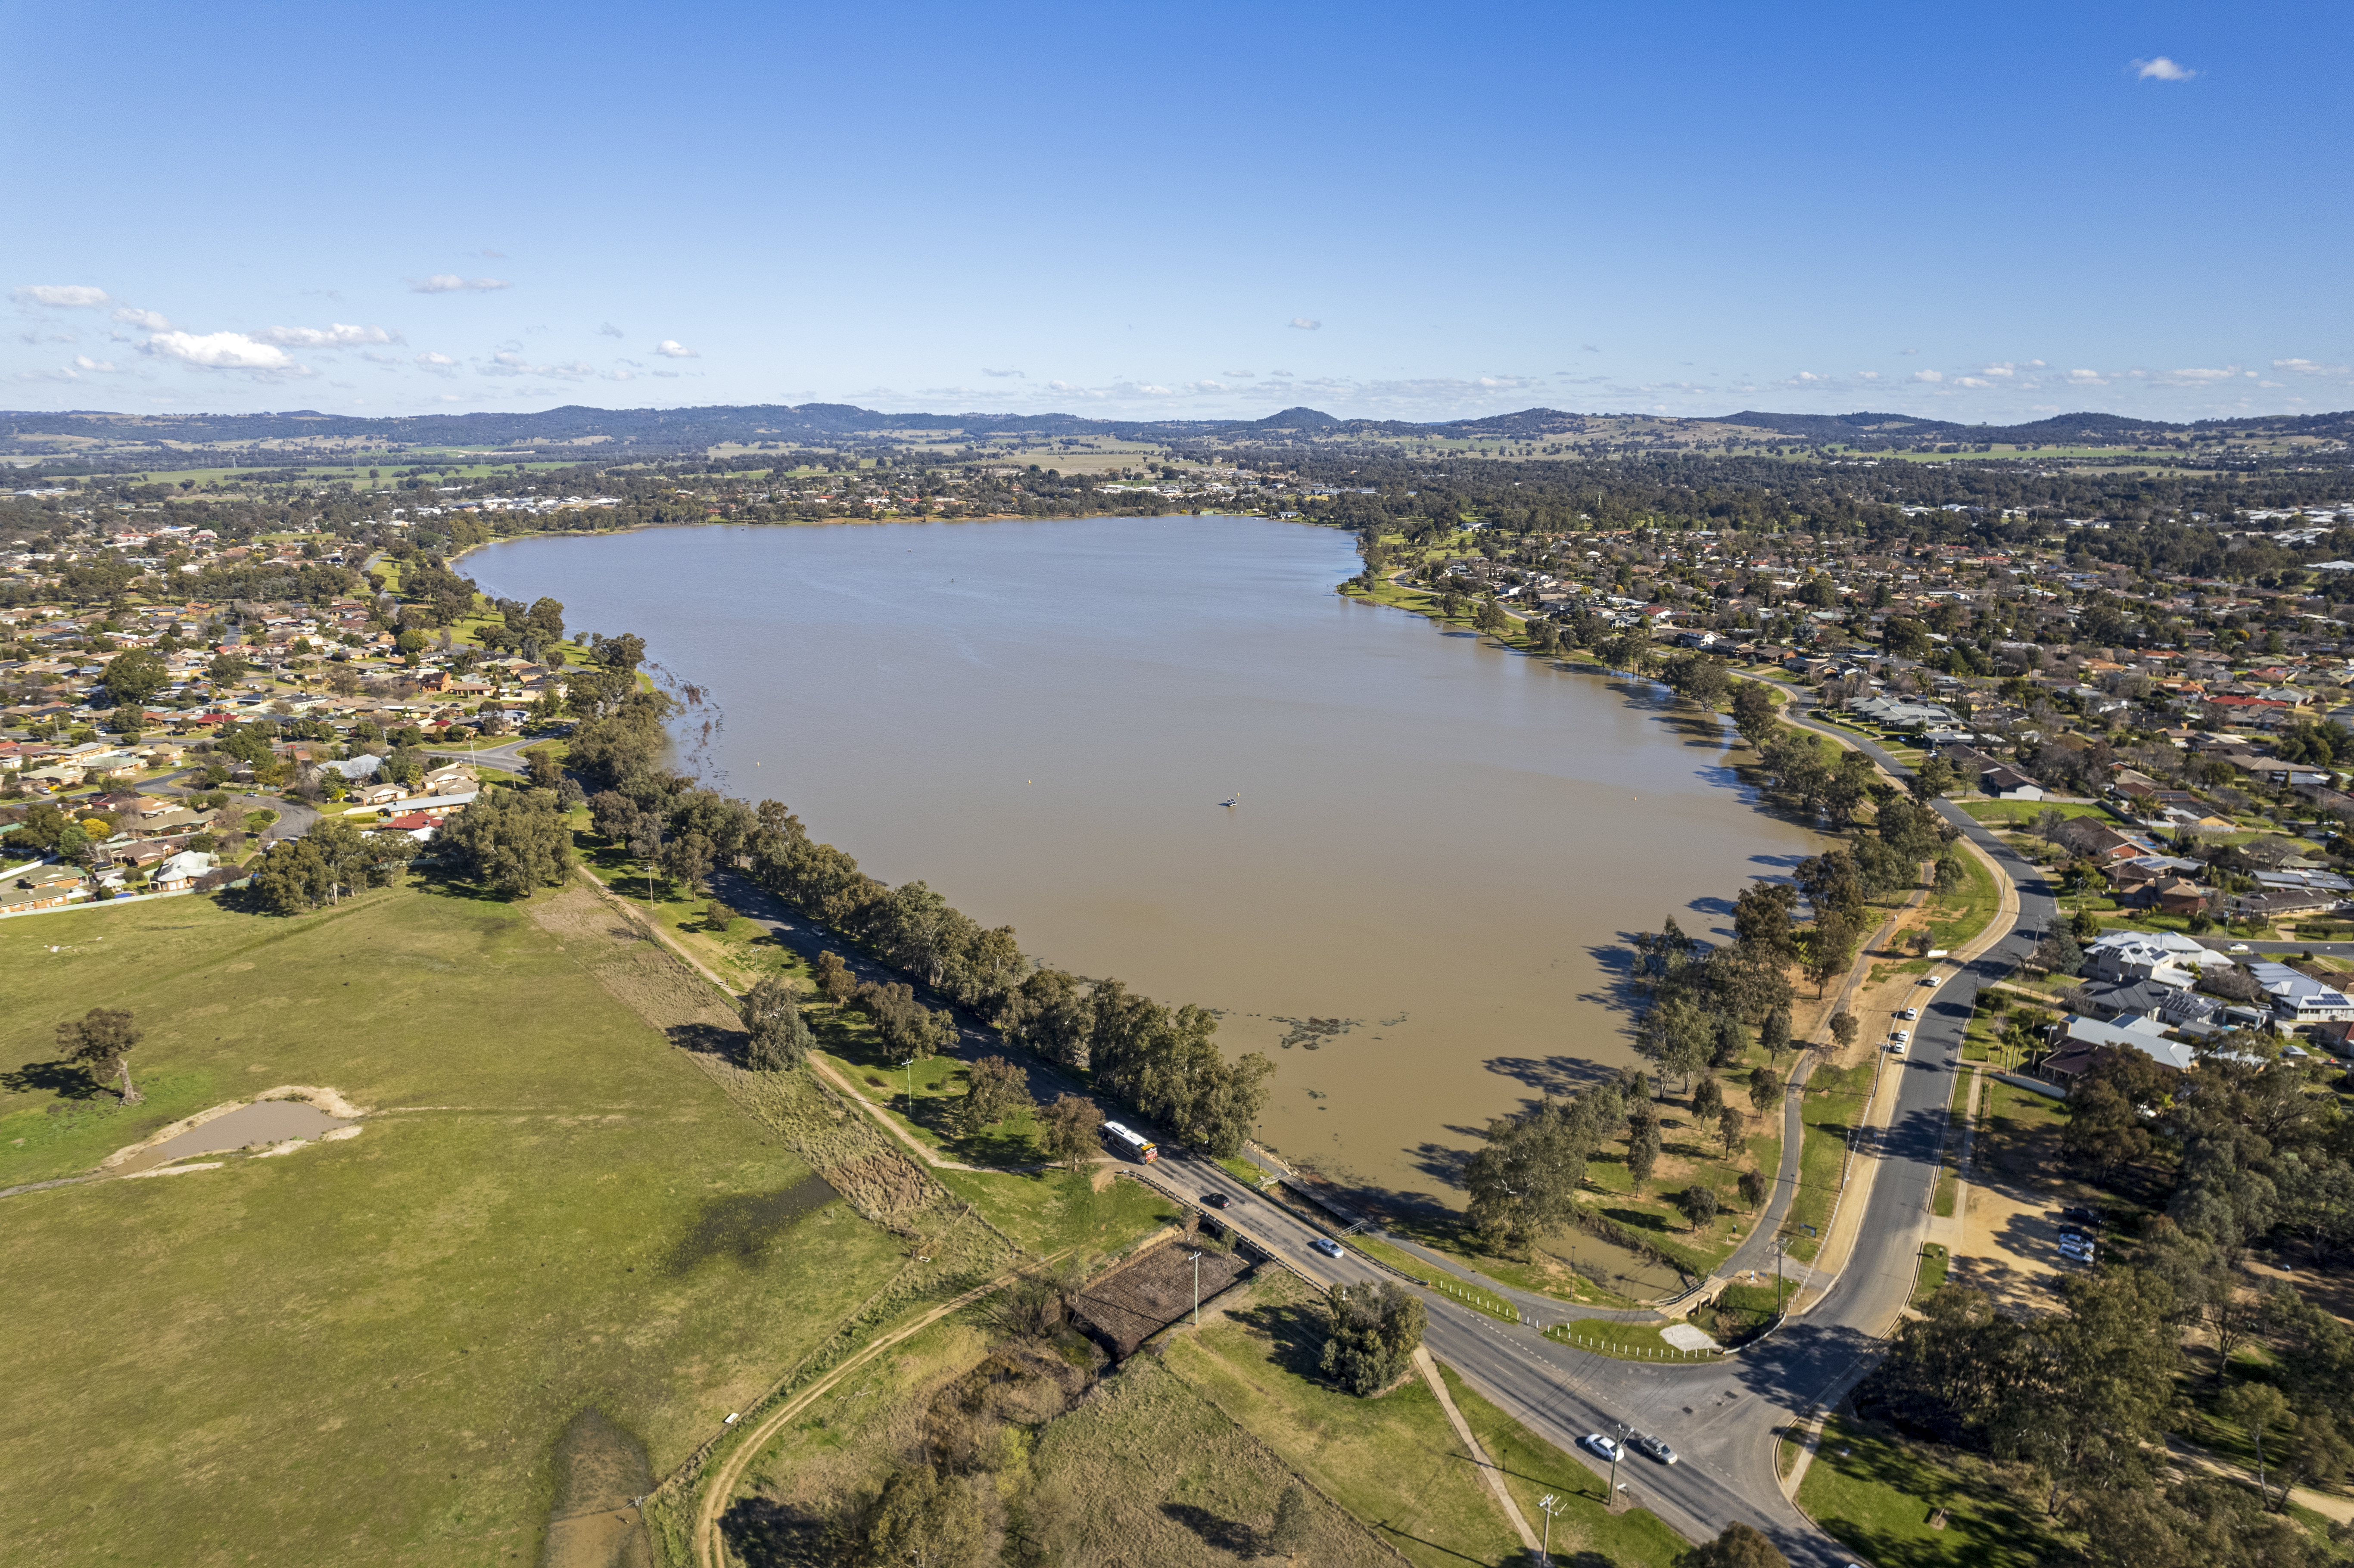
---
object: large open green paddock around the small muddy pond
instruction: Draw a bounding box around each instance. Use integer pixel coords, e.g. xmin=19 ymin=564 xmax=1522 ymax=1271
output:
xmin=0 ymin=890 xmax=906 ymax=1563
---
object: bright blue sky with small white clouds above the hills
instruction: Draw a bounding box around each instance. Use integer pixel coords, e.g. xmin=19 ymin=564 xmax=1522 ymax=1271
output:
xmin=0 ymin=0 xmax=2354 ymax=421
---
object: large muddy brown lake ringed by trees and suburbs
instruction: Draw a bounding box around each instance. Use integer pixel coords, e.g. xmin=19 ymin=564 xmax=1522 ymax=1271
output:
xmin=466 ymin=516 xmax=1815 ymax=1224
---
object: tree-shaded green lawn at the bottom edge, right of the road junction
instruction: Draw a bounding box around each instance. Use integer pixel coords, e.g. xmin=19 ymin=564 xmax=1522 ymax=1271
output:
xmin=1798 ymin=1415 xmax=2074 ymax=1568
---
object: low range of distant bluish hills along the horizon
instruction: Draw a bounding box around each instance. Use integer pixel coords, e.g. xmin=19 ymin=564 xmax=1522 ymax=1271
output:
xmin=0 ymin=403 xmax=2354 ymax=461
